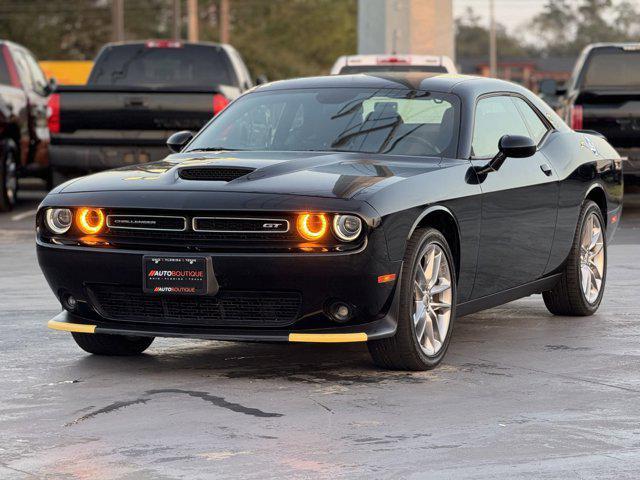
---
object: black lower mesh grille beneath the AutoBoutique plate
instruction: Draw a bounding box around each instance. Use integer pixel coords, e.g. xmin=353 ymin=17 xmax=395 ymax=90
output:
xmin=88 ymin=285 xmax=302 ymax=327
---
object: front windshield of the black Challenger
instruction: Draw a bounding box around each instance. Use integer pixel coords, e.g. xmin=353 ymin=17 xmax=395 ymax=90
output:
xmin=189 ymin=88 xmax=459 ymax=157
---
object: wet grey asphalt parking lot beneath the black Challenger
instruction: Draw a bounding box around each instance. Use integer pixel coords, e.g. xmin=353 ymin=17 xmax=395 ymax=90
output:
xmin=0 ymin=182 xmax=640 ymax=480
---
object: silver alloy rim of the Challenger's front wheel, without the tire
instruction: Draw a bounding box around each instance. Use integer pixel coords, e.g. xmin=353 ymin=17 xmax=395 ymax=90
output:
xmin=413 ymin=243 xmax=452 ymax=357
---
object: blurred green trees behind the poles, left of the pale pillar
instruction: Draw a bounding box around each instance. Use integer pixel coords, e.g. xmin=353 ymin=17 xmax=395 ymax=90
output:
xmin=0 ymin=0 xmax=357 ymax=79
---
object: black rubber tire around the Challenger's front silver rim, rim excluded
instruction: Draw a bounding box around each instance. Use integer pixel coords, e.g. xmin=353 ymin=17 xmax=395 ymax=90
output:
xmin=367 ymin=228 xmax=457 ymax=370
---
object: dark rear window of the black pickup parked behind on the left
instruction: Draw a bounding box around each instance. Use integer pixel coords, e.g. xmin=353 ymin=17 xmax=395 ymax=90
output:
xmin=89 ymin=44 xmax=237 ymax=87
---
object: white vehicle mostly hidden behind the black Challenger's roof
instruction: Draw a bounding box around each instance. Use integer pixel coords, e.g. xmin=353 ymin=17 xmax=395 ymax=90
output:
xmin=331 ymin=55 xmax=457 ymax=75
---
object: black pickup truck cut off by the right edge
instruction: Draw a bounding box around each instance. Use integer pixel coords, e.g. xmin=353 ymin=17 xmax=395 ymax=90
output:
xmin=558 ymin=43 xmax=640 ymax=180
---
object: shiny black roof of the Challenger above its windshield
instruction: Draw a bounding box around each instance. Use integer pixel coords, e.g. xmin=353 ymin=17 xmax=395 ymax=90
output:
xmin=255 ymin=72 xmax=527 ymax=96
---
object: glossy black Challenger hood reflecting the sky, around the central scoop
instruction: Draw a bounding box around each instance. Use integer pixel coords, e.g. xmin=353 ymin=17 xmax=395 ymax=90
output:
xmin=54 ymin=151 xmax=441 ymax=198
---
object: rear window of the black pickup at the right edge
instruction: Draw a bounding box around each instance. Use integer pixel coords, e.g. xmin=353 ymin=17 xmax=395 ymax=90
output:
xmin=582 ymin=48 xmax=640 ymax=90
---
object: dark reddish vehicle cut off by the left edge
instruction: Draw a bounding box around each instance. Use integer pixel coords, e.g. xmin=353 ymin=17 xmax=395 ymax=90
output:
xmin=0 ymin=40 xmax=55 ymax=211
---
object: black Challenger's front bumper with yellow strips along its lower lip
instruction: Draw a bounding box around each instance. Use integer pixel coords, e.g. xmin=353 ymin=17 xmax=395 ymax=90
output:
xmin=37 ymin=239 xmax=401 ymax=341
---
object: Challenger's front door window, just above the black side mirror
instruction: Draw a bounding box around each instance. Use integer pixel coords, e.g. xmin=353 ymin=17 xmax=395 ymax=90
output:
xmin=471 ymin=96 xmax=530 ymax=158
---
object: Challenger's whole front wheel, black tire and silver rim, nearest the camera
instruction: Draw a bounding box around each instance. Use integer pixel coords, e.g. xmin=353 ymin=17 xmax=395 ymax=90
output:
xmin=368 ymin=228 xmax=456 ymax=370
